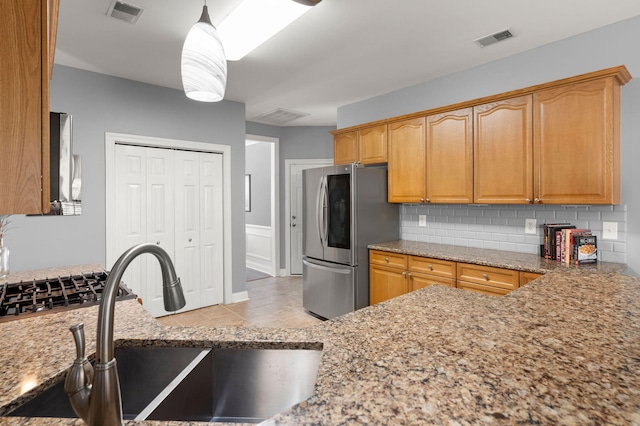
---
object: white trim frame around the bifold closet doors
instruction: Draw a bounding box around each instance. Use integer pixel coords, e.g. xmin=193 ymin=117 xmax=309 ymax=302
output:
xmin=104 ymin=132 xmax=235 ymax=303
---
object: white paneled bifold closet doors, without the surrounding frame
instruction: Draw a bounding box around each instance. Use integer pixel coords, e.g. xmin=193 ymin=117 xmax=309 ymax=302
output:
xmin=115 ymin=145 xmax=224 ymax=317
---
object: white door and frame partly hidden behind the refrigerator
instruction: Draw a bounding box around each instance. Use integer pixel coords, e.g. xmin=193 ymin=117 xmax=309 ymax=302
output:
xmin=285 ymin=158 xmax=333 ymax=275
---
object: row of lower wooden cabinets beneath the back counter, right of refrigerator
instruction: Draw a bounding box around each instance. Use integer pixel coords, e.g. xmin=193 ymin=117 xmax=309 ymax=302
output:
xmin=369 ymin=250 xmax=542 ymax=305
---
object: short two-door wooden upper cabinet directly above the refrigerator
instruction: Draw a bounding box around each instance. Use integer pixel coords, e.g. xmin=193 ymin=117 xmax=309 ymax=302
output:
xmin=333 ymin=124 xmax=387 ymax=164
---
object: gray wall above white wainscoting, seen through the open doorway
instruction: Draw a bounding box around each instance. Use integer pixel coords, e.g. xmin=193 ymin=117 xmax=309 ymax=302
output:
xmin=245 ymin=142 xmax=273 ymax=226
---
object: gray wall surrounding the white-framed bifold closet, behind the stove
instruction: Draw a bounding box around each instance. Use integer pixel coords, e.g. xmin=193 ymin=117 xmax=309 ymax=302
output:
xmin=6 ymin=66 xmax=246 ymax=292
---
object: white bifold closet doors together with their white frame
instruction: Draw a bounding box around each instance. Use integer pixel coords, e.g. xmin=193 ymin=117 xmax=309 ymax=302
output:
xmin=105 ymin=133 xmax=232 ymax=316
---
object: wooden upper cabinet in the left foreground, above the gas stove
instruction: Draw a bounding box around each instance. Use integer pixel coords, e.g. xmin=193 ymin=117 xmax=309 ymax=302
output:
xmin=0 ymin=0 xmax=58 ymax=214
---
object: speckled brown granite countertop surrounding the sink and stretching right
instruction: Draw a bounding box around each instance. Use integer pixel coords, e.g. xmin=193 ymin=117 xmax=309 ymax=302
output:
xmin=0 ymin=248 xmax=640 ymax=425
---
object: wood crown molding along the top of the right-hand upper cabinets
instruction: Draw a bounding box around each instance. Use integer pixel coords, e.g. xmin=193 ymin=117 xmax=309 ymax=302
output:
xmin=329 ymin=65 xmax=632 ymax=136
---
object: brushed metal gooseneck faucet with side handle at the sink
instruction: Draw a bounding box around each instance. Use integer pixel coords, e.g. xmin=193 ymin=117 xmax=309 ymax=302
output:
xmin=64 ymin=244 xmax=185 ymax=426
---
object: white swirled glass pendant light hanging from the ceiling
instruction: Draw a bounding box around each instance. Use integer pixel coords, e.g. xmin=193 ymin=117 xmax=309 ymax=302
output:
xmin=182 ymin=0 xmax=227 ymax=102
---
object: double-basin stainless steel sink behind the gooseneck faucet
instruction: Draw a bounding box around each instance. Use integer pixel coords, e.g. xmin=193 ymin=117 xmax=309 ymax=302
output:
xmin=9 ymin=347 xmax=322 ymax=423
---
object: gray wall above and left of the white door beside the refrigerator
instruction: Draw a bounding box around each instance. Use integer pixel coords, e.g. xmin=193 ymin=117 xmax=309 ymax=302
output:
xmin=247 ymin=122 xmax=336 ymax=269
